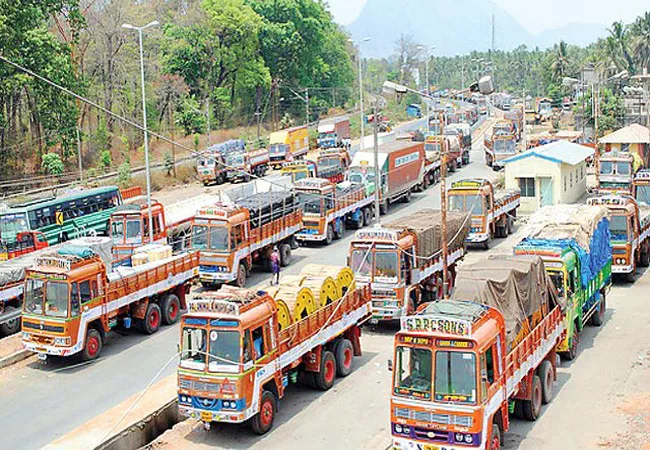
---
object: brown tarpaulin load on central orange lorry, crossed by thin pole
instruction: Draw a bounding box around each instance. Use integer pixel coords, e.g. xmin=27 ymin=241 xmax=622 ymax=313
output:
xmin=383 ymin=209 xmax=471 ymax=266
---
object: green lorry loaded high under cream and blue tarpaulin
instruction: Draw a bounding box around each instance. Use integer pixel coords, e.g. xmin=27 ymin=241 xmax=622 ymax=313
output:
xmin=514 ymin=205 xmax=612 ymax=360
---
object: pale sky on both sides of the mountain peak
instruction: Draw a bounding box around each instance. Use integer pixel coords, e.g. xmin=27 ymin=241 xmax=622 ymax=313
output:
xmin=326 ymin=0 xmax=650 ymax=35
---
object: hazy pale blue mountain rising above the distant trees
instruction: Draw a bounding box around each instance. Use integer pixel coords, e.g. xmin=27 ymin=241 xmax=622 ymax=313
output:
xmin=347 ymin=0 xmax=533 ymax=57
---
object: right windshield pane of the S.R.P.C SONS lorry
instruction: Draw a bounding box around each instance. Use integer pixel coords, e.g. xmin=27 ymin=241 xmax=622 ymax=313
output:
xmin=434 ymin=351 xmax=476 ymax=404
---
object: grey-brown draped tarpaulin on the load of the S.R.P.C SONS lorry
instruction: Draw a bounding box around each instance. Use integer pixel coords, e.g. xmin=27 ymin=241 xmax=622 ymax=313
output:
xmin=451 ymin=255 xmax=564 ymax=351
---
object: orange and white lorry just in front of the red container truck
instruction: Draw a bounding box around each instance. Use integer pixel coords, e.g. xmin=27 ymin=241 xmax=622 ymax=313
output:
xmin=294 ymin=178 xmax=375 ymax=244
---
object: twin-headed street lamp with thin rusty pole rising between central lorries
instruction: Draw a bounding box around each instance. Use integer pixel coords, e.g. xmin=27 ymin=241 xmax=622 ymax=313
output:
xmin=382 ymin=76 xmax=494 ymax=297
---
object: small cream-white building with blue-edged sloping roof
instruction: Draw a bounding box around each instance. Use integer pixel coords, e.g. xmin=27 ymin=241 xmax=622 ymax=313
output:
xmin=503 ymin=141 xmax=594 ymax=212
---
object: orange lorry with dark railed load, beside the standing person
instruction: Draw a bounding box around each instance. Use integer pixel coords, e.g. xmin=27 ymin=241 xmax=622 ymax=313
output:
xmin=191 ymin=179 xmax=303 ymax=287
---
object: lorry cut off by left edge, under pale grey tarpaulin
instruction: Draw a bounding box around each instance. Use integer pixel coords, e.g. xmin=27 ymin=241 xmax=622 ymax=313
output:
xmin=0 ymin=237 xmax=110 ymax=335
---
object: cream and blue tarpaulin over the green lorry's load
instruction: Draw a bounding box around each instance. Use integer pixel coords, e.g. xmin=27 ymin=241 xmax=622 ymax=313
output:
xmin=515 ymin=205 xmax=612 ymax=287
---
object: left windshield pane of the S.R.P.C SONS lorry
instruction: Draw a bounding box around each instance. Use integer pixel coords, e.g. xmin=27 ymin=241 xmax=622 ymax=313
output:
xmin=393 ymin=347 xmax=432 ymax=400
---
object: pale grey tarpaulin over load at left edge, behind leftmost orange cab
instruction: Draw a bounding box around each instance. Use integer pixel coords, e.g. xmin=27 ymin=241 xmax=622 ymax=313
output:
xmin=0 ymin=237 xmax=112 ymax=288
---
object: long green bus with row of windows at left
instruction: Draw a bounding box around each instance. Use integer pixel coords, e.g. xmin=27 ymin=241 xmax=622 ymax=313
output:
xmin=0 ymin=186 xmax=122 ymax=245
